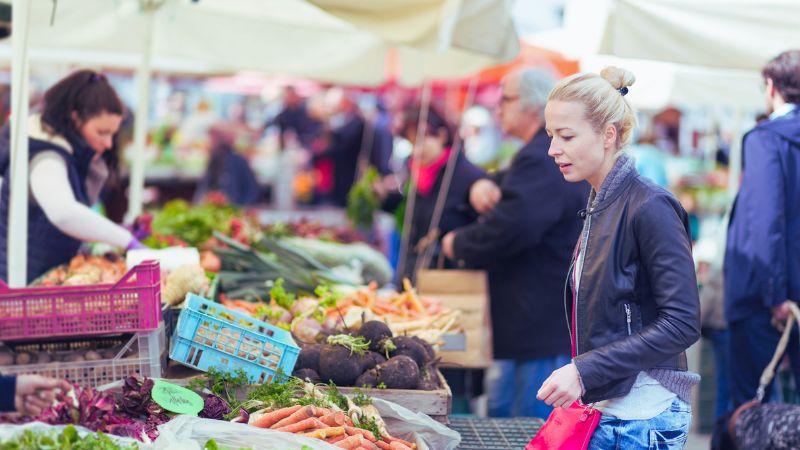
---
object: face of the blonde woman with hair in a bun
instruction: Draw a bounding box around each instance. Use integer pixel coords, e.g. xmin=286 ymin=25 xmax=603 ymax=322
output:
xmin=544 ymin=100 xmax=616 ymax=190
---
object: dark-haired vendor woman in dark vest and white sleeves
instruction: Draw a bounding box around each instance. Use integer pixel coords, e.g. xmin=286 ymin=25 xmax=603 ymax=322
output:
xmin=0 ymin=70 xmax=141 ymax=283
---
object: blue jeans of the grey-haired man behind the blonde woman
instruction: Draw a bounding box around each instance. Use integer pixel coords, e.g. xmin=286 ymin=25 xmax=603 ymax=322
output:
xmin=486 ymin=355 xmax=570 ymax=419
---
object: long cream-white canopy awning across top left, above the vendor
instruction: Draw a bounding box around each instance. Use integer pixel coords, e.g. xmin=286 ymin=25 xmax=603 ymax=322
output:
xmin=0 ymin=0 xmax=519 ymax=85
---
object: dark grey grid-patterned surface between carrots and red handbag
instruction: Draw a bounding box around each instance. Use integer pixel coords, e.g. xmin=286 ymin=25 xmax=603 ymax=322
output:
xmin=449 ymin=416 xmax=544 ymax=450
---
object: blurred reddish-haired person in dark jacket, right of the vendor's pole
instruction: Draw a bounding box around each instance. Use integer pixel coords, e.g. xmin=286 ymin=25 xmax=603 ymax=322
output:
xmin=195 ymin=123 xmax=261 ymax=206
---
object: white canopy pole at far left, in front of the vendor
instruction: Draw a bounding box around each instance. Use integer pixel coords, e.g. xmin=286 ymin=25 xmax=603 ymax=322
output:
xmin=7 ymin=0 xmax=31 ymax=287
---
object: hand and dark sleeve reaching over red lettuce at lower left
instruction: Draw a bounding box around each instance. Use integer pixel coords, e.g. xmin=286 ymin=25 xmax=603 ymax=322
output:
xmin=0 ymin=375 xmax=72 ymax=416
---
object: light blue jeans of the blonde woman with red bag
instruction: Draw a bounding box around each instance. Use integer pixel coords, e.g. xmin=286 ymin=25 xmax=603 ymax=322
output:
xmin=589 ymin=399 xmax=692 ymax=450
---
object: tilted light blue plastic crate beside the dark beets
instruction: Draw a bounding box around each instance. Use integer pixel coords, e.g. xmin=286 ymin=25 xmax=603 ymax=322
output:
xmin=169 ymin=294 xmax=300 ymax=384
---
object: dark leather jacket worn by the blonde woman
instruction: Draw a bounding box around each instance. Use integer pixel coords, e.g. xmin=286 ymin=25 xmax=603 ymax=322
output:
xmin=565 ymin=170 xmax=700 ymax=403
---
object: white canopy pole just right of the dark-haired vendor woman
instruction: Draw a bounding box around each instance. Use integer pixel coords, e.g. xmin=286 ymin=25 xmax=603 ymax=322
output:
xmin=125 ymin=6 xmax=156 ymax=223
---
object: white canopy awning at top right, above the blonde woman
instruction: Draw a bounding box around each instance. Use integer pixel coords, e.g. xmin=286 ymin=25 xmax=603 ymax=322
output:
xmin=599 ymin=0 xmax=800 ymax=71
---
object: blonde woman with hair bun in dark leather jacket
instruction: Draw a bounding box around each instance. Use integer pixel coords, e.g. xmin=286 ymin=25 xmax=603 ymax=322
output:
xmin=537 ymin=67 xmax=700 ymax=449
